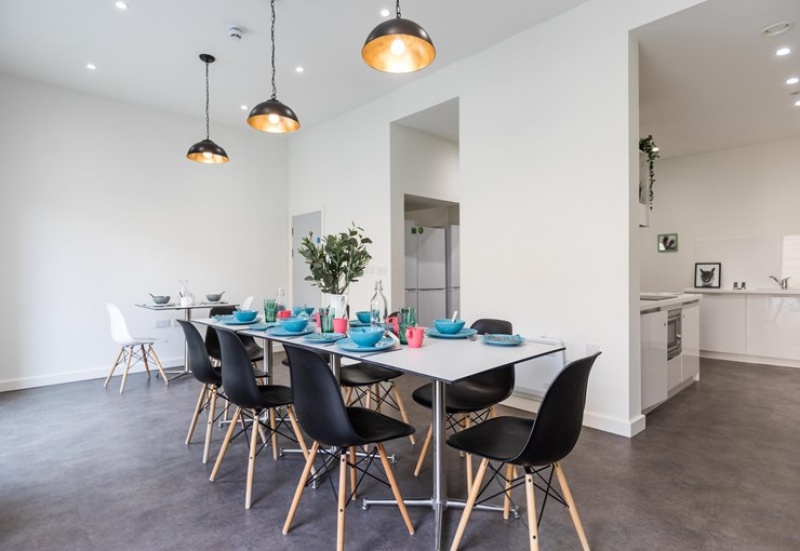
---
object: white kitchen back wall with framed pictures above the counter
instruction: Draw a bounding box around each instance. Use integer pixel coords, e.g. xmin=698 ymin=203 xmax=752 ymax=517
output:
xmin=640 ymin=139 xmax=800 ymax=291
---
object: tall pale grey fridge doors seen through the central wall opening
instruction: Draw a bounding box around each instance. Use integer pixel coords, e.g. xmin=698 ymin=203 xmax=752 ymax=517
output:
xmin=405 ymin=221 xmax=461 ymax=327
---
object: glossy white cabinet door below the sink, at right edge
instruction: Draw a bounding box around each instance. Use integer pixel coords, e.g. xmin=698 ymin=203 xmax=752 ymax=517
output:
xmin=747 ymin=295 xmax=800 ymax=360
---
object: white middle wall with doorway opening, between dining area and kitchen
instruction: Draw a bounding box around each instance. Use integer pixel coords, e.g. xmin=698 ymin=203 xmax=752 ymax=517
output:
xmin=289 ymin=0 xmax=698 ymax=440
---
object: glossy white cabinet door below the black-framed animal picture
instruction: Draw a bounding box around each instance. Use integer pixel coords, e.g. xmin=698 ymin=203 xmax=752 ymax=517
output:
xmin=700 ymin=294 xmax=747 ymax=354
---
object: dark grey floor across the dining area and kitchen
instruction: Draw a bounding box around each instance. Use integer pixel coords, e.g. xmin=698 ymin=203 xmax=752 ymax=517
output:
xmin=0 ymin=360 xmax=800 ymax=551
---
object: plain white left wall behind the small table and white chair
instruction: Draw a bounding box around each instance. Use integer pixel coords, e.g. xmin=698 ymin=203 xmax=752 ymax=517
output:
xmin=0 ymin=75 xmax=288 ymax=392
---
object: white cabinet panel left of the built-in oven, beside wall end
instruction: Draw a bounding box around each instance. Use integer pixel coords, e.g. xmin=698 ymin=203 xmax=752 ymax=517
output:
xmin=641 ymin=310 xmax=668 ymax=410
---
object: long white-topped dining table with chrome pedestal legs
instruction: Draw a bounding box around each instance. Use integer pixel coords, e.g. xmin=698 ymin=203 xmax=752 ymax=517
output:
xmin=194 ymin=318 xmax=564 ymax=551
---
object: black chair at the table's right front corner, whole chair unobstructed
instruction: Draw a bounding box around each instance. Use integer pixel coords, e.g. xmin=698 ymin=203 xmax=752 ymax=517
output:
xmin=447 ymin=352 xmax=600 ymax=551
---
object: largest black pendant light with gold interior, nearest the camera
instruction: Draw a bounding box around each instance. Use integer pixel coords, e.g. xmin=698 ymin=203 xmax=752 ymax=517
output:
xmin=361 ymin=0 xmax=436 ymax=73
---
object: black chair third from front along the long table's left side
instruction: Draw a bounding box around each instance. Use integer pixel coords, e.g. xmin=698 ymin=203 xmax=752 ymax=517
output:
xmin=177 ymin=320 xmax=227 ymax=463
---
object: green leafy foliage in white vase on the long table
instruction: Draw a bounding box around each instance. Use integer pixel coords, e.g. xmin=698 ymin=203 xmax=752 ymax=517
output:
xmin=297 ymin=223 xmax=372 ymax=295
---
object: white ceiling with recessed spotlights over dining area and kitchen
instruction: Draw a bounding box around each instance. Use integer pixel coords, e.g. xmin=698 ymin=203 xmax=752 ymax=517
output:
xmin=0 ymin=0 xmax=800 ymax=158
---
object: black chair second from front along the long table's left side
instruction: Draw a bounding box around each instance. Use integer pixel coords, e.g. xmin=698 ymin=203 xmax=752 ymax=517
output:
xmin=210 ymin=330 xmax=308 ymax=509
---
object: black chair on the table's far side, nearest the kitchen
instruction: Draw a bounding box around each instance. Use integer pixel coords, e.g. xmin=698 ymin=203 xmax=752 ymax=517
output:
xmin=411 ymin=318 xmax=514 ymax=486
